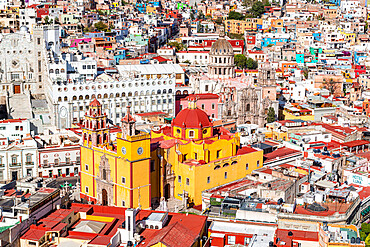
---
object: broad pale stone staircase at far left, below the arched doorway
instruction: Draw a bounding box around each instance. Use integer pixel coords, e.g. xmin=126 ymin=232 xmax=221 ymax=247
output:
xmin=7 ymin=94 xmax=33 ymax=119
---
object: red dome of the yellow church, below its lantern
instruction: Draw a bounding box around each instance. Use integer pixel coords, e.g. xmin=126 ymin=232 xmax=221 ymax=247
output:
xmin=172 ymin=108 xmax=212 ymax=129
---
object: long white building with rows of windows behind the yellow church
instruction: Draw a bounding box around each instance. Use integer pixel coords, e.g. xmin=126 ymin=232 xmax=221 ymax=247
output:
xmin=50 ymin=64 xmax=185 ymax=128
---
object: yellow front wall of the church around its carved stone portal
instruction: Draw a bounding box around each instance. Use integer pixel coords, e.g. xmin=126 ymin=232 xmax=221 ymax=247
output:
xmin=81 ymin=131 xmax=151 ymax=208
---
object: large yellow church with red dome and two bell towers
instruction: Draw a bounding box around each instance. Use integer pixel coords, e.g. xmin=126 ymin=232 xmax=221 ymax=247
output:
xmin=81 ymin=98 xmax=263 ymax=208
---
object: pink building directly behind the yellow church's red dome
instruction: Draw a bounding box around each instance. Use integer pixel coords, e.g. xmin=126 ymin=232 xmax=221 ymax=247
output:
xmin=176 ymin=93 xmax=219 ymax=119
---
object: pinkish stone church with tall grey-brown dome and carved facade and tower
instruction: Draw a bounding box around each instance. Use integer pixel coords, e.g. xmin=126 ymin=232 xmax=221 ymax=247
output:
xmin=190 ymin=29 xmax=278 ymax=127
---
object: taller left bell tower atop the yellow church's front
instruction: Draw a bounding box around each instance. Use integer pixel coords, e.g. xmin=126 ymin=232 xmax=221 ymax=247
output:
xmin=82 ymin=99 xmax=110 ymax=147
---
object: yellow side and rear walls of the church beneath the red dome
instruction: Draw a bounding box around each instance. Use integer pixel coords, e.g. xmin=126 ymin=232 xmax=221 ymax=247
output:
xmin=162 ymin=135 xmax=263 ymax=205
